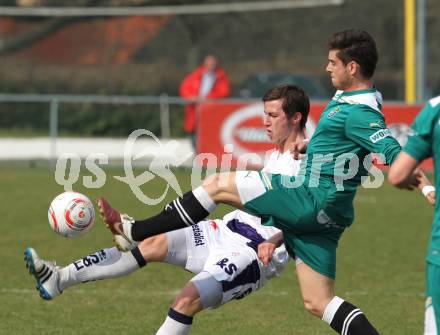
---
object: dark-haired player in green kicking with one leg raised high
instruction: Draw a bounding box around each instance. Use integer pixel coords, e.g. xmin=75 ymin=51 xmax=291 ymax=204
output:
xmin=101 ymin=30 xmax=401 ymax=335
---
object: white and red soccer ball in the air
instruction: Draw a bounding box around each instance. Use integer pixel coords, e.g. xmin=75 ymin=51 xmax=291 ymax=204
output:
xmin=47 ymin=192 xmax=95 ymax=237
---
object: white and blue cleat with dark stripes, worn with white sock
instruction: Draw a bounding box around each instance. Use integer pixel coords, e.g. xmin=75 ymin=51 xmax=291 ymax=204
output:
xmin=24 ymin=247 xmax=63 ymax=300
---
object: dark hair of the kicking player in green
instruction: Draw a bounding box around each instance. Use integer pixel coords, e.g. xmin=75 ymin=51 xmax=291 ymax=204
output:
xmin=328 ymin=29 xmax=379 ymax=79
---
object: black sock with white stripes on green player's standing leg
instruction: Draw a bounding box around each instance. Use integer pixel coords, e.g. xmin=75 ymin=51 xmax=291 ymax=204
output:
xmin=330 ymin=301 xmax=379 ymax=335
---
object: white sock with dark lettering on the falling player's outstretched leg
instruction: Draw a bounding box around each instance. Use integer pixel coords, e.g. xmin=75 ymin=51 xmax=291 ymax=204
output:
xmin=59 ymin=247 xmax=140 ymax=290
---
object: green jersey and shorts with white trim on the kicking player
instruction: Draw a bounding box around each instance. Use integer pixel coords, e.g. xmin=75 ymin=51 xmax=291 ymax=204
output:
xmin=242 ymin=89 xmax=401 ymax=278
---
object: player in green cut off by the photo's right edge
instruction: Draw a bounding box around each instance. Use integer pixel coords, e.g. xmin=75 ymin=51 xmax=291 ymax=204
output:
xmin=388 ymin=96 xmax=440 ymax=335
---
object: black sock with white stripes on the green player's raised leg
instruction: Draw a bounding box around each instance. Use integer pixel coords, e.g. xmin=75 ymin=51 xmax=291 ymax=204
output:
xmin=131 ymin=192 xmax=209 ymax=241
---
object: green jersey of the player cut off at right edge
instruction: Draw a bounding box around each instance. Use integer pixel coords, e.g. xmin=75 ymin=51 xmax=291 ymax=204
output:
xmin=403 ymin=96 xmax=440 ymax=265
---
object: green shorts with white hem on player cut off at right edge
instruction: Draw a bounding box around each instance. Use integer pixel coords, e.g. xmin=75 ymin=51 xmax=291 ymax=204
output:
xmin=425 ymin=262 xmax=440 ymax=329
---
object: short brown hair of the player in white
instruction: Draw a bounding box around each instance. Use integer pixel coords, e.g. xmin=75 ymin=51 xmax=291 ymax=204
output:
xmin=262 ymin=85 xmax=310 ymax=129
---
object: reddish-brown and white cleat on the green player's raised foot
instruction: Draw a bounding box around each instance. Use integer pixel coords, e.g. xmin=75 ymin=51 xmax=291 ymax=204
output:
xmin=98 ymin=197 xmax=138 ymax=251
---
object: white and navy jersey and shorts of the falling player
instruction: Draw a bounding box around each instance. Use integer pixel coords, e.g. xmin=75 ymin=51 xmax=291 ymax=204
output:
xmin=167 ymin=151 xmax=301 ymax=304
